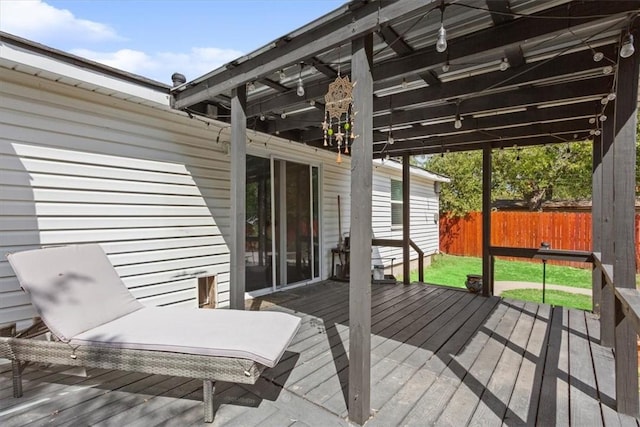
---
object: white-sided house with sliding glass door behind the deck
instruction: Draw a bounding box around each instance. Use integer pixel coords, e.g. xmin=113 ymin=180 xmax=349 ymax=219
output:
xmin=0 ymin=33 xmax=447 ymax=325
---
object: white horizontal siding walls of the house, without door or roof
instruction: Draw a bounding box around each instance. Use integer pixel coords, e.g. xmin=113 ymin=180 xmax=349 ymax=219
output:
xmin=0 ymin=69 xmax=438 ymax=324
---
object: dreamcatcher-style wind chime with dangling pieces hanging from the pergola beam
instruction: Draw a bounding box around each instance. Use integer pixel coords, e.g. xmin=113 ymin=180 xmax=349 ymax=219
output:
xmin=322 ymin=71 xmax=356 ymax=163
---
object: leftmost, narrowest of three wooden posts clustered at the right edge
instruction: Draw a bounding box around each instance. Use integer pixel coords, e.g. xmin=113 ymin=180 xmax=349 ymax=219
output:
xmin=591 ymin=135 xmax=602 ymax=315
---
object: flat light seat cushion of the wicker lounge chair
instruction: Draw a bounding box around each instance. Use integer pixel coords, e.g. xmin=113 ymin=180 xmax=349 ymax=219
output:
xmin=71 ymin=307 xmax=300 ymax=367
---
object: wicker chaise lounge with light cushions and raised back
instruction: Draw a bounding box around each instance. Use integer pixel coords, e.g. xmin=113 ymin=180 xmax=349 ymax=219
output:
xmin=0 ymin=244 xmax=300 ymax=422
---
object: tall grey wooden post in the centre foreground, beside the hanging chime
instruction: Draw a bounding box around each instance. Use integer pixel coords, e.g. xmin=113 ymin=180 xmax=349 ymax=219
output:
xmin=348 ymin=34 xmax=373 ymax=425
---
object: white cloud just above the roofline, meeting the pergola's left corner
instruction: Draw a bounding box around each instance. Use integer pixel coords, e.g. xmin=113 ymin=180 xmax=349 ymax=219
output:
xmin=71 ymin=47 xmax=242 ymax=84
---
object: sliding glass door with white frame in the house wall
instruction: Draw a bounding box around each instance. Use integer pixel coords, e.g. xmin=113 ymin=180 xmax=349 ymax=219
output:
xmin=246 ymin=156 xmax=320 ymax=291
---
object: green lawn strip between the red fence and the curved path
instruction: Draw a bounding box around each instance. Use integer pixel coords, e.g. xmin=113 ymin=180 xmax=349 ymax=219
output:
xmin=411 ymin=254 xmax=591 ymax=289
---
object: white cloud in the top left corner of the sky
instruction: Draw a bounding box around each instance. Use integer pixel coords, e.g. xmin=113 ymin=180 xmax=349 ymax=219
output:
xmin=0 ymin=0 xmax=122 ymax=43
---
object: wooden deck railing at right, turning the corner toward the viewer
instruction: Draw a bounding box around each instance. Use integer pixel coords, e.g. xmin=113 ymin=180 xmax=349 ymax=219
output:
xmin=489 ymin=246 xmax=640 ymax=416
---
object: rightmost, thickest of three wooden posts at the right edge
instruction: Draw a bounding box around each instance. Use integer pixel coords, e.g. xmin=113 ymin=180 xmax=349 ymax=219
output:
xmin=613 ymin=29 xmax=640 ymax=417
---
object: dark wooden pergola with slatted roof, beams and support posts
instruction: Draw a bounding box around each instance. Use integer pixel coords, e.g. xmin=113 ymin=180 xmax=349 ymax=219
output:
xmin=172 ymin=0 xmax=640 ymax=424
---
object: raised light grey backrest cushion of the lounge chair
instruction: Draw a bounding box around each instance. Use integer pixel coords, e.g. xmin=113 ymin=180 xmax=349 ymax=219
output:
xmin=7 ymin=244 xmax=143 ymax=342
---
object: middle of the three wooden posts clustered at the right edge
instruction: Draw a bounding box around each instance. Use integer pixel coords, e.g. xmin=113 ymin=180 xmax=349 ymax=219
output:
xmin=592 ymin=102 xmax=615 ymax=347
